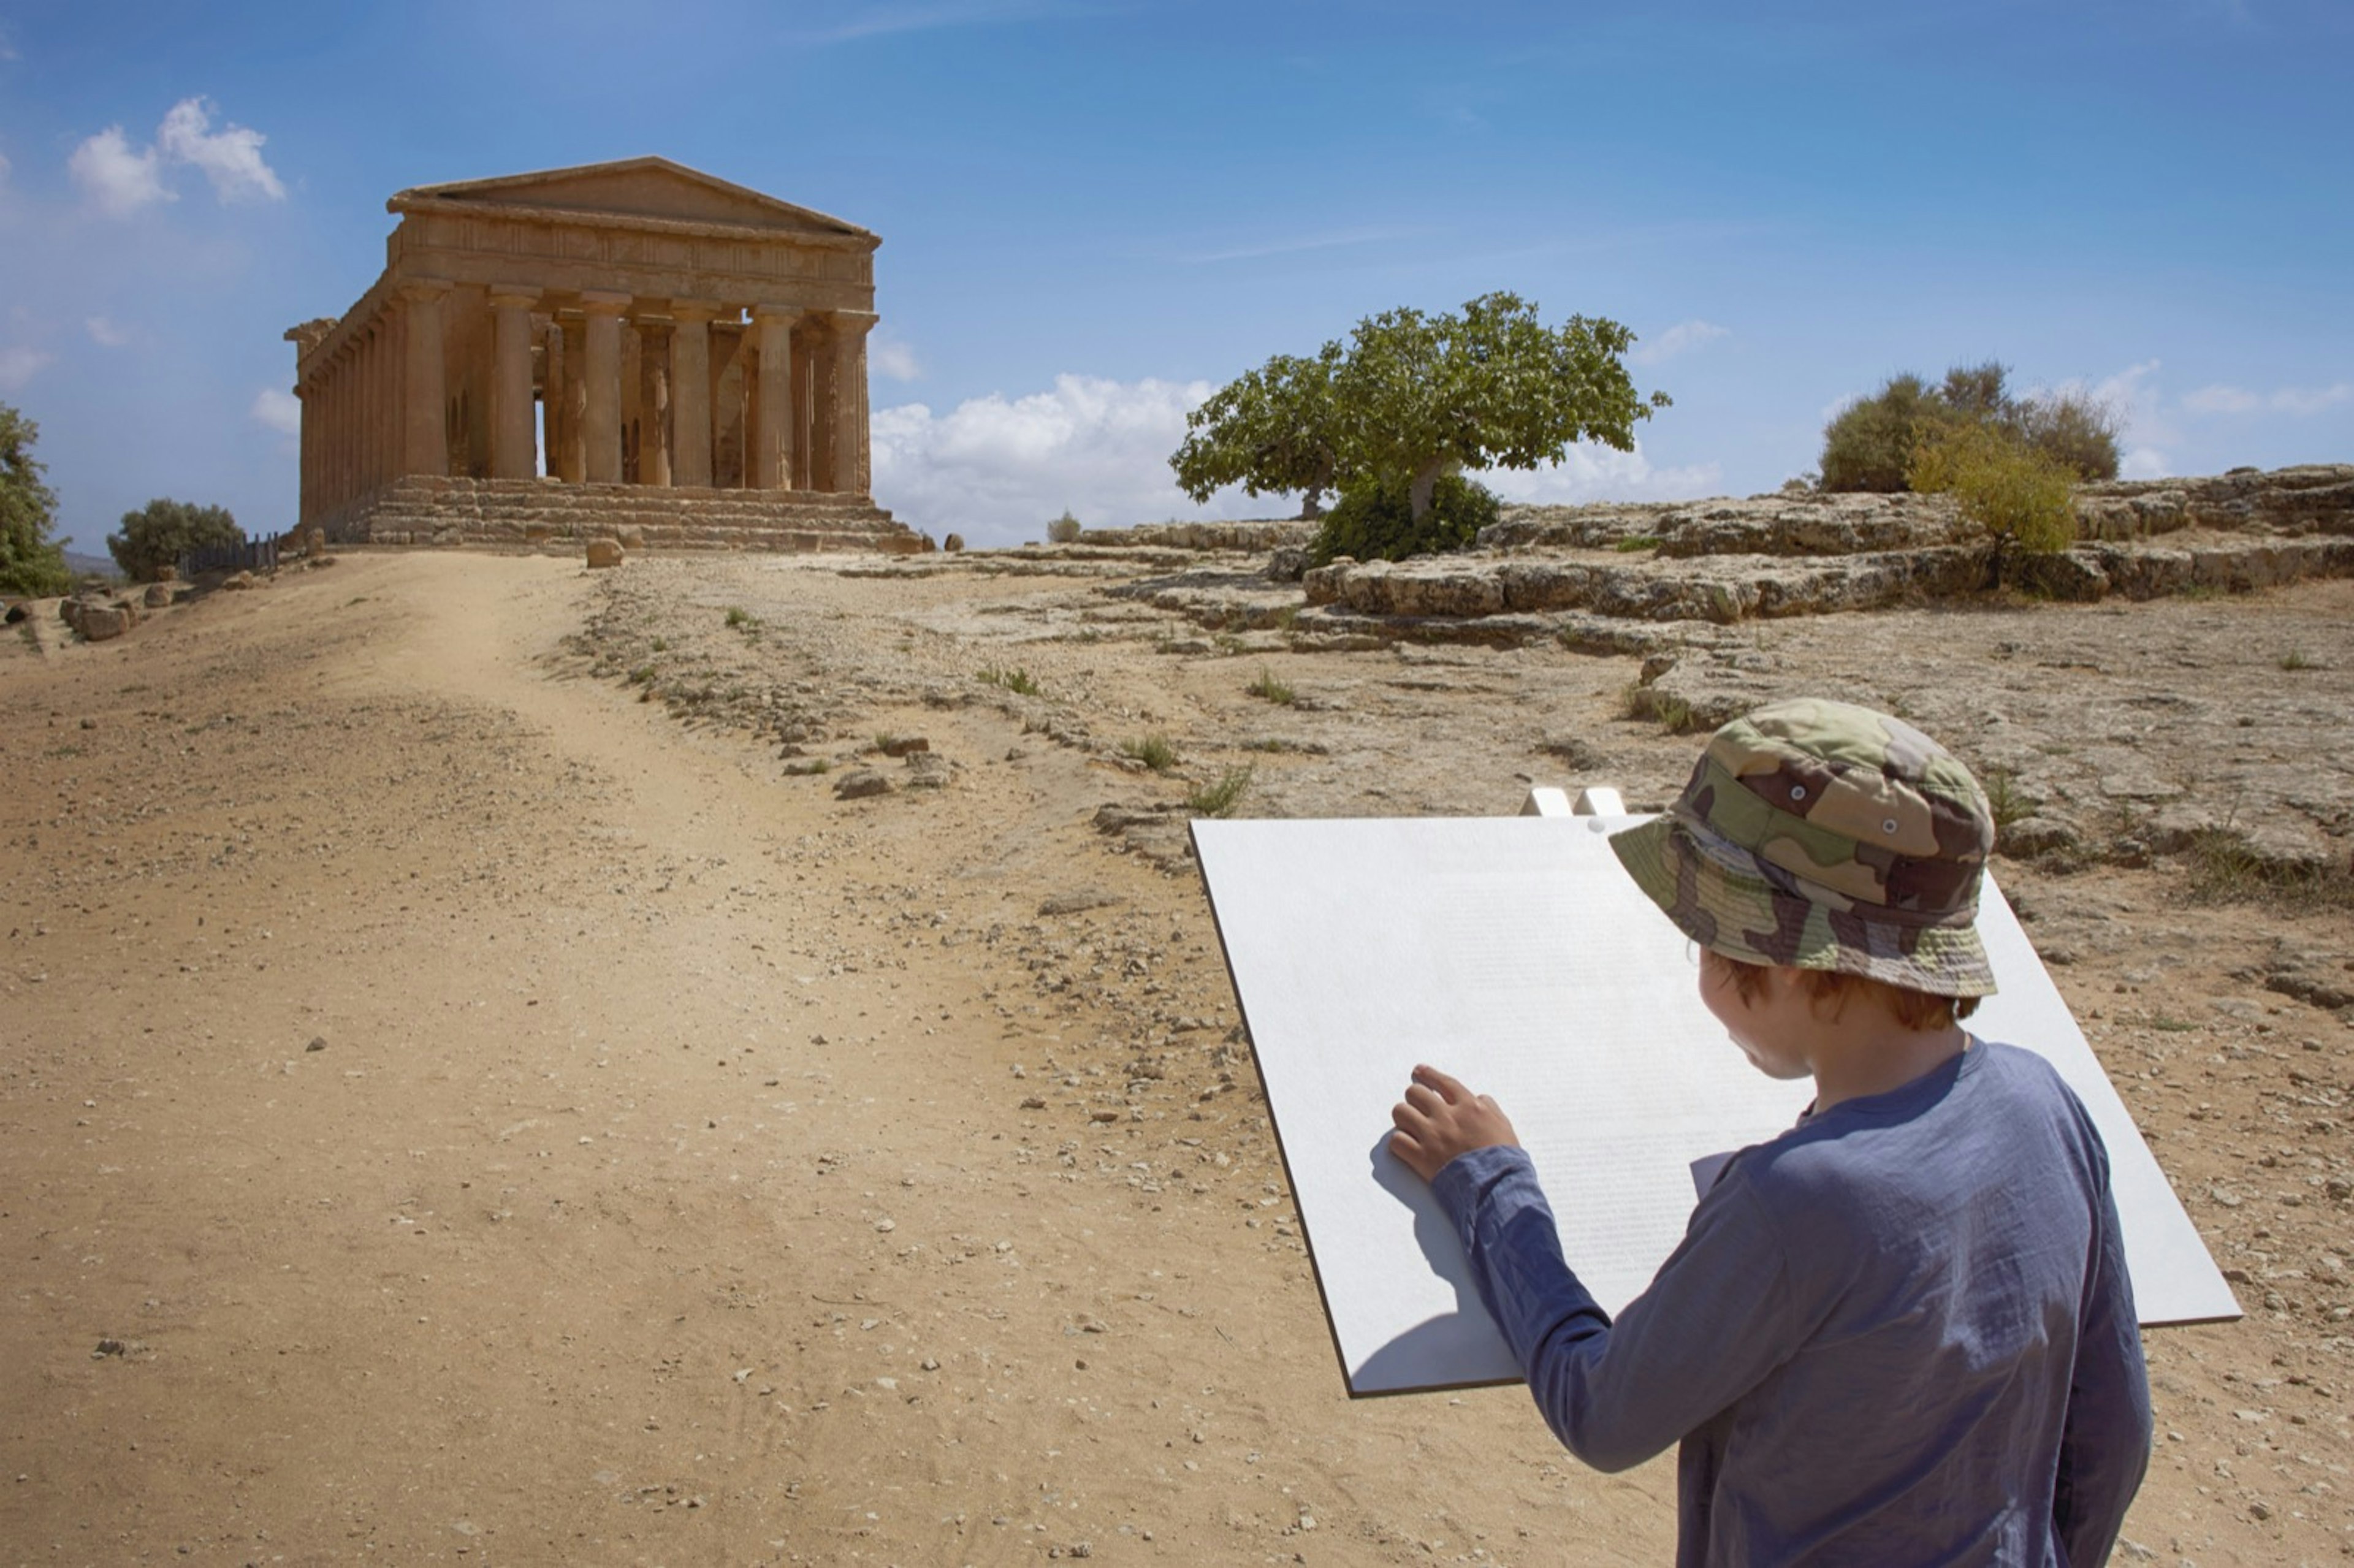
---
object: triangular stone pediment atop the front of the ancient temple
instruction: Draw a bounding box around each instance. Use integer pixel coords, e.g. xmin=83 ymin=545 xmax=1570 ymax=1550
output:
xmin=386 ymin=158 xmax=874 ymax=240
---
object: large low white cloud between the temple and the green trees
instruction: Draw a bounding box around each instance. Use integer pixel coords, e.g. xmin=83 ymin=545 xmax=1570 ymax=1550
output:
xmin=871 ymin=375 xmax=1290 ymax=544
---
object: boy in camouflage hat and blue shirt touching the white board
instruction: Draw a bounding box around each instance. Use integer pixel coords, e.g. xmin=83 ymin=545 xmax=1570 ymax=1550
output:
xmin=1391 ymin=702 xmax=2149 ymax=1568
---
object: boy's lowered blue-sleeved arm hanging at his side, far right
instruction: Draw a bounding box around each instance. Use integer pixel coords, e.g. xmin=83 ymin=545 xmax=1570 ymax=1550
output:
xmin=2052 ymin=1168 xmax=2152 ymax=1568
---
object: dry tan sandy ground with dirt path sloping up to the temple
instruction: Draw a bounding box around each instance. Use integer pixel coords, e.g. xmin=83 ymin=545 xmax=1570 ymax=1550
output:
xmin=0 ymin=544 xmax=2354 ymax=1566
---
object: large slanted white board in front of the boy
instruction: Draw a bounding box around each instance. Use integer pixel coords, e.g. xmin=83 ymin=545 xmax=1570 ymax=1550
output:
xmin=1194 ymin=817 xmax=2239 ymax=1396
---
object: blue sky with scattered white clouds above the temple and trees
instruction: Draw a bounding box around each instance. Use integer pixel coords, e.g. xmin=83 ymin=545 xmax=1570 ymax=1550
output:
xmin=0 ymin=0 xmax=2354 ymax=549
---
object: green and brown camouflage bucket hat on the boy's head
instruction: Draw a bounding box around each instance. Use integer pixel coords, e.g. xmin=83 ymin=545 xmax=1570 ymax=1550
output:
xmin=1610 ymin=699 xmax=1994 ymax=996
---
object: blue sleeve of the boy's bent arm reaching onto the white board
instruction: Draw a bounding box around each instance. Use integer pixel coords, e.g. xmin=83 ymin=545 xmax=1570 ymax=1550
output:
xmin=1431 ymin=1146 xmax=1799 ymax=1469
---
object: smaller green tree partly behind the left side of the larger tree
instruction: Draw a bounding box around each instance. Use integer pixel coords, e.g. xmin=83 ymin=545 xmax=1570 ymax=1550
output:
xmin=1170 ymin=344 xmax=1342 ymax=518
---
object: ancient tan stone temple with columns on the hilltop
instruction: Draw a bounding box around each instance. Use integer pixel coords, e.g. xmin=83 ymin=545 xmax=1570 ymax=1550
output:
xmin=287 ymin=158 xmax=918 ymax=549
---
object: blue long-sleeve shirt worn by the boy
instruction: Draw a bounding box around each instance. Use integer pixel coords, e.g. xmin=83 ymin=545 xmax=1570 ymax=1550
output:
xmin=1431 ymin=1043 xmax=2149 ymax=1568
